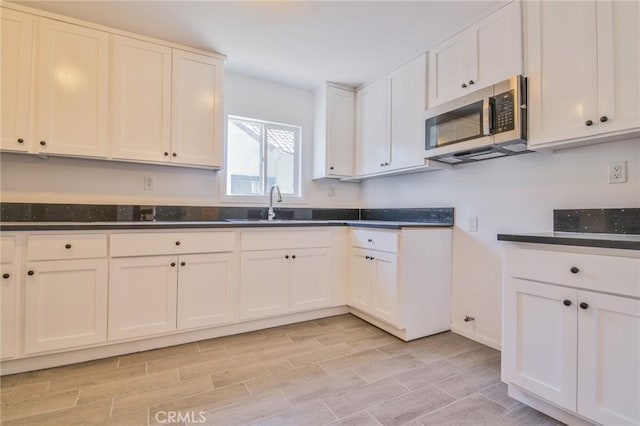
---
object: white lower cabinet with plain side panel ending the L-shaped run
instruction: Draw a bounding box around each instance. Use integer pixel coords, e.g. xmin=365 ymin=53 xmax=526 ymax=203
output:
xmin=349 ymin=228 xmax=452 ymax=340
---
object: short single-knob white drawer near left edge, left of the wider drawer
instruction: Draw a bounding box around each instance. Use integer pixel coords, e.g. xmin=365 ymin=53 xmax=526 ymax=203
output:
xmin=27 ymin=234 xmax=107 ymax=261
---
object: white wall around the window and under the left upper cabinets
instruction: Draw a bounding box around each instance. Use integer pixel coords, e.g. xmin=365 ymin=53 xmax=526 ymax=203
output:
xmin=0 ymin=73 xmax=360 ymax=207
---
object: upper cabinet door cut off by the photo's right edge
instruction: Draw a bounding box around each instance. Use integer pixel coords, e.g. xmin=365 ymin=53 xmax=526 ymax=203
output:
xmin=596 ymin=0 xmax=640 ymax=133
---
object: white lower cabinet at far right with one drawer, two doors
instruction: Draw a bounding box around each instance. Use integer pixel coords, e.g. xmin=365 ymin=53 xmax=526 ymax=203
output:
xmin=502 ymin=244 xmax=640 ymax=425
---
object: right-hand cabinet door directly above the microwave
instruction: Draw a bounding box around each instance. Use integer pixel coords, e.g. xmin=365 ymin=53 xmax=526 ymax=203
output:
xmin=467 ymin=1 xmax=522 ymax=90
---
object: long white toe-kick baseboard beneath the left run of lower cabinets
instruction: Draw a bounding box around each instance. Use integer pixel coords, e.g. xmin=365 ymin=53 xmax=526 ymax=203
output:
xmin=0 ymin=306 xmax=349 ymax=375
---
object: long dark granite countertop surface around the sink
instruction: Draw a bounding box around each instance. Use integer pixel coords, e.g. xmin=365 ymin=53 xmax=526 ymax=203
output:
xmin=0 ymin=219 xmax=453 ymax=232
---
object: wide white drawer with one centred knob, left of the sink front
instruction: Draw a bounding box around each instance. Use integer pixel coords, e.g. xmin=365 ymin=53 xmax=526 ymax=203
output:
xmin=111 ymin=232 xmax=236 ymax=257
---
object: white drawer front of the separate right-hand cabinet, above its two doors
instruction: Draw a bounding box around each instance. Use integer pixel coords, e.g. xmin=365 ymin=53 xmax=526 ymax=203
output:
xmin=505 ymin=247 xmax=640 ymax=297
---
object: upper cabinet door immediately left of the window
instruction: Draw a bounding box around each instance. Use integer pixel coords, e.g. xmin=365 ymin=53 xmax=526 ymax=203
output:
xmin=171 ymin=49 xmax=224 ymax=167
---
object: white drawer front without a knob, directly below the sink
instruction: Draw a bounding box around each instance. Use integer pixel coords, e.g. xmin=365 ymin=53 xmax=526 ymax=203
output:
xmin=241 ymin=230 xmax=331 ymax=250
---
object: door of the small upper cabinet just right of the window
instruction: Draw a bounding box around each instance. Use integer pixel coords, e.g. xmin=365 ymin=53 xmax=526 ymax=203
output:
xmin=326 ymin=87 xmax=355 ymax=177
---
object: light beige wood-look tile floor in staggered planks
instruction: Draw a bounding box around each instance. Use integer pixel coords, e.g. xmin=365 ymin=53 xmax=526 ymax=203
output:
xmin=0 ymin=315 xmax=559 ymax=426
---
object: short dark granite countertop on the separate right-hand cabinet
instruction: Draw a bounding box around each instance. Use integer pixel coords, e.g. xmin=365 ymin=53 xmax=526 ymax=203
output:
xmin=498 ymin=232 xmax=640 ymax=250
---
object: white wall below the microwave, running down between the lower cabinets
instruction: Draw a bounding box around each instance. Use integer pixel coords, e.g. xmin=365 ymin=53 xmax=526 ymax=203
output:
xmin=362 ymin=139 xmax=640 ymax=347
